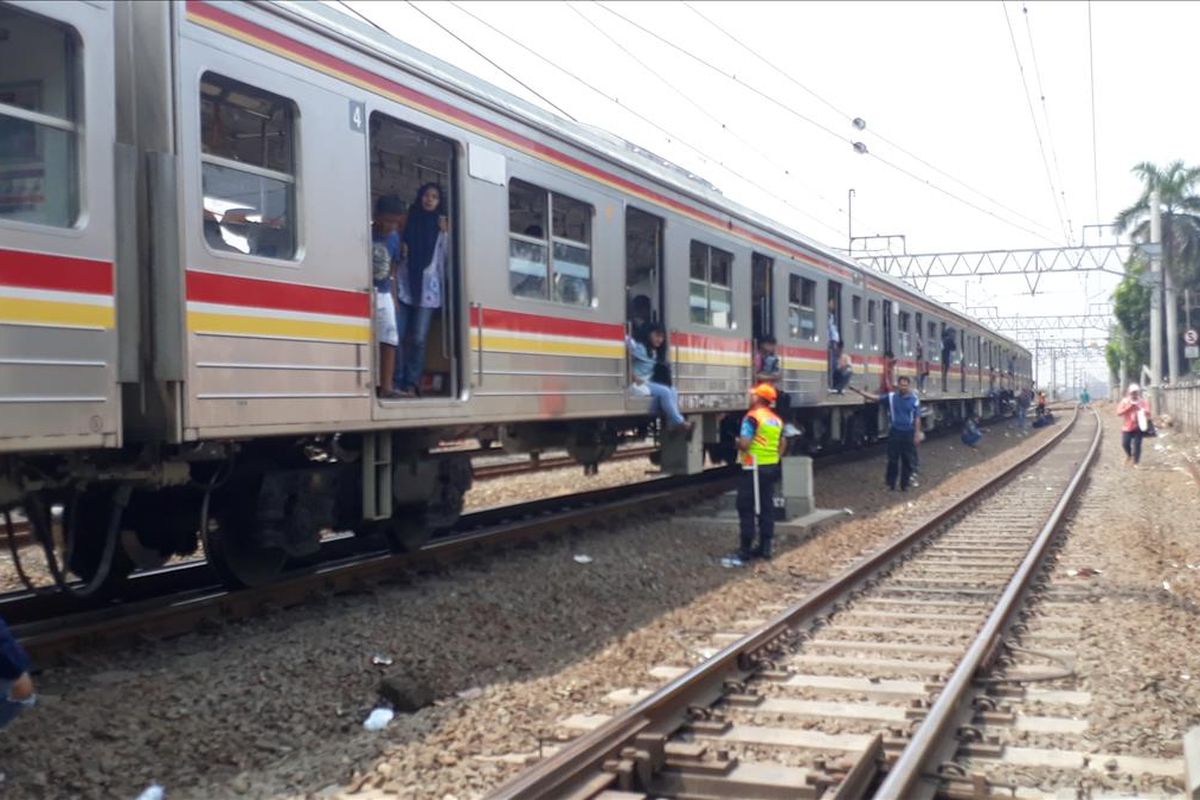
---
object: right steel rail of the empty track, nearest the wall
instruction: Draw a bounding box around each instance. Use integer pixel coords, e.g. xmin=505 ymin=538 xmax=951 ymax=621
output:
xmin=875 ymin=410 xmax=1103 ymax=800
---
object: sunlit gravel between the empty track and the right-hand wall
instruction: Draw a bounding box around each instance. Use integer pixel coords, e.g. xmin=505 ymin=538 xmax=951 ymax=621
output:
xmin=1054 ymin=407 xmax=1200 ymax=758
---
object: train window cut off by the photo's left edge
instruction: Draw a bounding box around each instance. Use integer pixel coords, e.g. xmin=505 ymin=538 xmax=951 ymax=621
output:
xmin=0 ymin=4 xmax=79 ymax=228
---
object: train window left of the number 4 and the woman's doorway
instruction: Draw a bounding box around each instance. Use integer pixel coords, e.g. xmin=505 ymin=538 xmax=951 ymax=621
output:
xmin=200 ymin=72 xmax=296 ymax=259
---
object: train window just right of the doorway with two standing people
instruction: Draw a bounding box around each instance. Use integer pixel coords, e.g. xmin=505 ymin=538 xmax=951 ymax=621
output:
xmin=509 ymin=179 xmax=592 ymax=306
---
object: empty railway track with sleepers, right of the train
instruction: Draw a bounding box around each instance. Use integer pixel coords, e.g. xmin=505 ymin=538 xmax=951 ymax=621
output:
xmin=490 ymin=413 xmax=1183 ymax=800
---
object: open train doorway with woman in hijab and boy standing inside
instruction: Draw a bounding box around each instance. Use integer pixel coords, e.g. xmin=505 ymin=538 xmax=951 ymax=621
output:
xmin=368 ymin=112 xmax=462 ymax=403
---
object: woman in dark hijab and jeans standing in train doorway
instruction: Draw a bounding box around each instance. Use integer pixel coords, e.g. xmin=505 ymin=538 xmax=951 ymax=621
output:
xmin=396 ymin=184 xmax=449 ymax=397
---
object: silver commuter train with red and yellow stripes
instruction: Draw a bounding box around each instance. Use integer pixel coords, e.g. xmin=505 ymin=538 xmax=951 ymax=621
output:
xmin=0 ymin=0 xmax=1031 ymax=595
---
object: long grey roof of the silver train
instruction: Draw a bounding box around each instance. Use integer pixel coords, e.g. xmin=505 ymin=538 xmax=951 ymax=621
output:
xmin=270 ymin=0 xmax=1024 ymax=349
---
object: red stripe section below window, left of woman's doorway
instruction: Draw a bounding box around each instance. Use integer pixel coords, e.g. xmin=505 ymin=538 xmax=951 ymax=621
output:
xmin=187 ymin=270 xmax=371 ymax=317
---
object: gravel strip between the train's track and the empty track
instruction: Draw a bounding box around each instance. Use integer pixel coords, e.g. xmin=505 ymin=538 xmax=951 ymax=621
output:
xmin=0 ymin=429 xmax=1056 ymax=800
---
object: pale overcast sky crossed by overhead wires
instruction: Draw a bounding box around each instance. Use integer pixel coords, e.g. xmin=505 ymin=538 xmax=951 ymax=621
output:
xmin=331 ymin=0 xmax=1200 ymax=388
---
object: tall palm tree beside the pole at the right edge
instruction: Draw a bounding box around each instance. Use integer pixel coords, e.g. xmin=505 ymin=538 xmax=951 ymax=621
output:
xmin=1114 ymin=161 xmax=1200 ymax=381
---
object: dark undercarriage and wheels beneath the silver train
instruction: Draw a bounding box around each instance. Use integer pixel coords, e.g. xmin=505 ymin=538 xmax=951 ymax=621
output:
xmin=0 ymin=399 xmax=1000 ymax=597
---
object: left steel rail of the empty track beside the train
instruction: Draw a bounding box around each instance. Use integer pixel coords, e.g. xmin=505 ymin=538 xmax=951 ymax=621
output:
xmin=486 ymin=408 xmax=1079 ymax=800
